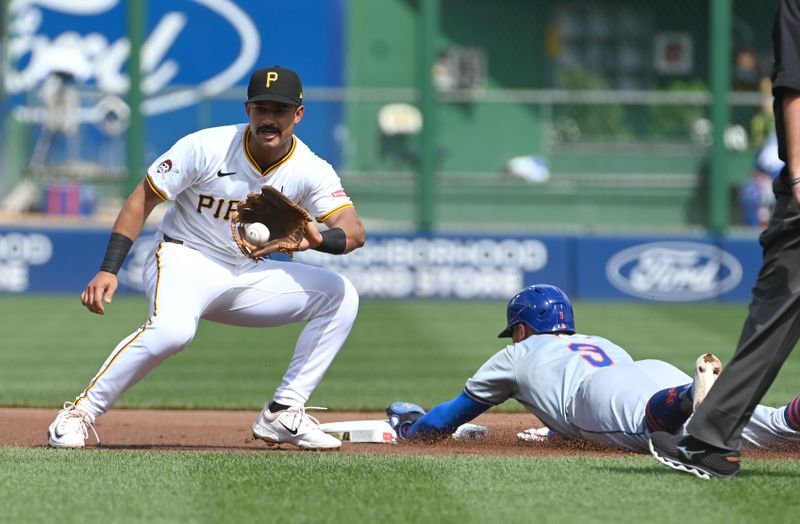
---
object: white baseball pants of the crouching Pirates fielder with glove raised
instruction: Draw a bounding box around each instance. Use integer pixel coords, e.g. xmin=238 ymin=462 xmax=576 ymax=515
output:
xmin=75 ymin=242 xmax=358 ymax=419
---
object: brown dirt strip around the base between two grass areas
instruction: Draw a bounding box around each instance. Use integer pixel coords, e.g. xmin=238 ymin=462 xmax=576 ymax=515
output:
xmin=6 ymin=408 xmax=800 ymax=460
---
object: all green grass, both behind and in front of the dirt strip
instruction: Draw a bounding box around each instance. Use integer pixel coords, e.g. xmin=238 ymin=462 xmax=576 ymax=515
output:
xmin=0 ymin=296 xmax=800 ymax=523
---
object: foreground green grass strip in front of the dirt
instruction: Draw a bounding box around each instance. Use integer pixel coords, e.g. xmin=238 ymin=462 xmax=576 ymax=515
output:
xmin=0 ymin=448 xmax=800 ymax=523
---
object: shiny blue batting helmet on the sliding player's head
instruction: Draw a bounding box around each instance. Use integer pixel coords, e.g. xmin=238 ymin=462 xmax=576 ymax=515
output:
xmin=497 ymin=284 xmax=575 ymax=338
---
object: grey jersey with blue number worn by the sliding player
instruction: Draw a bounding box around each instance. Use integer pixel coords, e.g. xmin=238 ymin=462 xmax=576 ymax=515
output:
xmin=465 ymin=335 xmax=633 ymax=438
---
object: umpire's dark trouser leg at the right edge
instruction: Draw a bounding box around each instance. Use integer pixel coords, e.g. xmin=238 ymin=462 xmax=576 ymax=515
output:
xmin=687 ymin=187 xmax=800 ymax=450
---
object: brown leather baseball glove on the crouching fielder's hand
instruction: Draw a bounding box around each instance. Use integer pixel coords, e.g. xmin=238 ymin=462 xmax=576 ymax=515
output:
xmin=231 ymin=186 xmax=311 ymax=260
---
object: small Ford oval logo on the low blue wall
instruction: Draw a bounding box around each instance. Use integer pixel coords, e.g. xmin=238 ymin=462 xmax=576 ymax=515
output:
xmin=606 ymin=242 xmax=742 ymax=302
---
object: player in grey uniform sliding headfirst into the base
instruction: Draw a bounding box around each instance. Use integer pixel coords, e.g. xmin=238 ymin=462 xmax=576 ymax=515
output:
xmin=387 ymin=284 xmax=800 ymax=452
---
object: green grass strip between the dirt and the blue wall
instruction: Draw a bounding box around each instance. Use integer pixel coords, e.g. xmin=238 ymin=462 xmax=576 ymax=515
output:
xmin=0 ymin=296 xmax=800 ymax=410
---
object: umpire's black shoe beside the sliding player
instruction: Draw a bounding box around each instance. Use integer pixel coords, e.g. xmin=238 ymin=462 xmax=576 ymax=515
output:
xmin=650 ymin=431 xmax=740 ymax=480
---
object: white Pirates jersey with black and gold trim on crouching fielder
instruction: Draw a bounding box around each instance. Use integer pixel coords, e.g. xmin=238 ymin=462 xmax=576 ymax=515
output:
xmin=147 ymin=124 xmax=353 ymax=266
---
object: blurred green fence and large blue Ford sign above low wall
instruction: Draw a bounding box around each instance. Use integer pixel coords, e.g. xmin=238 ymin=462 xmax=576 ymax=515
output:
xmin=0 ymin=0 xmax=781 ymax=232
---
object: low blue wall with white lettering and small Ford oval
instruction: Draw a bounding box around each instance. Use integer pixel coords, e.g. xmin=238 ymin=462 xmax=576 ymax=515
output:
xmin=0 ymin=227 xmax=761 ymax=302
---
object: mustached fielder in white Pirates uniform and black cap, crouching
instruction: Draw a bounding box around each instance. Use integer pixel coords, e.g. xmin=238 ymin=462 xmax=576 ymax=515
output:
xmin=49 ymin=66 xmax=364 ymax=449
